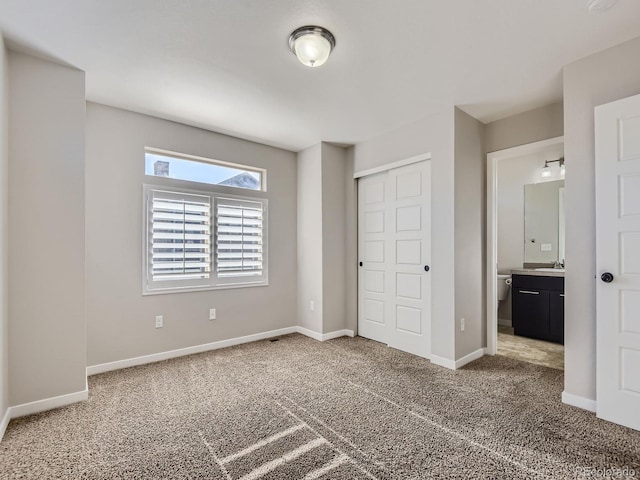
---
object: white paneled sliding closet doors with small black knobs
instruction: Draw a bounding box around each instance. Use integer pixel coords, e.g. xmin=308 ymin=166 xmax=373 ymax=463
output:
xmin=358 ymin=161 xmax=431 ymax=357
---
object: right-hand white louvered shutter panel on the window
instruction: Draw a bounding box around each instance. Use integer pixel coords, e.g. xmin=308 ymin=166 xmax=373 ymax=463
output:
xmin=216 ymin=198 xmax=266 ymax=283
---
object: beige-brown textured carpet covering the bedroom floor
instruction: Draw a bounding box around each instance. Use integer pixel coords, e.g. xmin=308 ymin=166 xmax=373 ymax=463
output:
xmin=0 ymin=335 xmax=640 ymax=480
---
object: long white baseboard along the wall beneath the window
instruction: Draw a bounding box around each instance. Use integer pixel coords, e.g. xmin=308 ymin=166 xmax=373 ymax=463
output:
xmin=87 ymin=327 xmax=298 ymax=376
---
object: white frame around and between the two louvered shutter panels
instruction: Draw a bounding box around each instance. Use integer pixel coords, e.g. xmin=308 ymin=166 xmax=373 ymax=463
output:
xmin=142 ymin=182 xmax=269 ymax=296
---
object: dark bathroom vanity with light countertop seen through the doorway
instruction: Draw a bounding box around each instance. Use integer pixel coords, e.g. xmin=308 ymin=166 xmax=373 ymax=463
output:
xmin=511 ymin=268 xmax=564 ymax=344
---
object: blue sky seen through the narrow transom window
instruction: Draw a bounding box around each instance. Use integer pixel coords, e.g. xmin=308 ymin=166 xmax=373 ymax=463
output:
xmin=144 ymin=152 xmax=261 ymax=190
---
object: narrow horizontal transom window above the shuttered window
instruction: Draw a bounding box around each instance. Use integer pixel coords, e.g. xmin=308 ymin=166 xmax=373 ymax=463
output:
xmin=144 ymin=148 xmax=266 ymax=191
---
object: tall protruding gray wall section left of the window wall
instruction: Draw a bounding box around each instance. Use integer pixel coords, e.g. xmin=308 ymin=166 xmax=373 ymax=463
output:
xmin=9 ymin=52 xmax=87 ymax=405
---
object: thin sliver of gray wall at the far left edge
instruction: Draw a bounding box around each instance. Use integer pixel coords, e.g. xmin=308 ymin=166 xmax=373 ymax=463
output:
xmin=0 ymin=32 xmax=9 ymax=424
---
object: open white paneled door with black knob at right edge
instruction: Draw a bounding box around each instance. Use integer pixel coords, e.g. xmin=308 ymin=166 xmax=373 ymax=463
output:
xmin=595 ymin=95 xmax=640 ymax=430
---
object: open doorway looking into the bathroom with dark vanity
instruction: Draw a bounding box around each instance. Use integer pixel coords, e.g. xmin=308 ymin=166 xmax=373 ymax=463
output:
xmin=487 ymin=137 xmax=564 ymax=368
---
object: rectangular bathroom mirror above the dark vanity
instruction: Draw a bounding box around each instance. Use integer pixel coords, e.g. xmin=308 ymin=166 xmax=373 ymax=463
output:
xmin=524 ymin=180 xmax=564 ymax=264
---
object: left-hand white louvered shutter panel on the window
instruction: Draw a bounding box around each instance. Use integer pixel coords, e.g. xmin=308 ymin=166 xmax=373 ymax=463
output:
xmin=147 ymin=190 xmax=211 ymax=288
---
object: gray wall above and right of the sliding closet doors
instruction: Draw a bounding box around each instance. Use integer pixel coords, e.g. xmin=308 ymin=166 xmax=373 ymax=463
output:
xmin=354 ymin=108 xmax=458 ymax=360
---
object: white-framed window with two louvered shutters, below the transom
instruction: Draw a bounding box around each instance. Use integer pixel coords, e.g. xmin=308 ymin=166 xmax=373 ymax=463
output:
xmin=143 ymin=185 xmax=267 ymax=294
